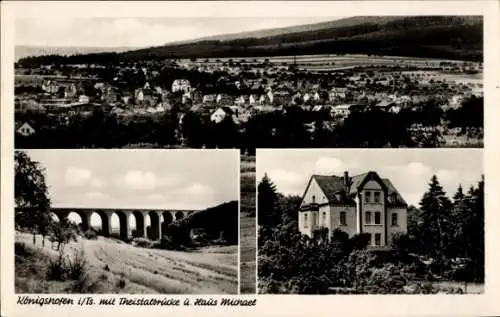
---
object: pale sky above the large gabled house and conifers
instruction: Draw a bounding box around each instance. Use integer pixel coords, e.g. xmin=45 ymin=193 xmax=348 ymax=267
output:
xmin=256 ymin=149 xmax=483 ymax=206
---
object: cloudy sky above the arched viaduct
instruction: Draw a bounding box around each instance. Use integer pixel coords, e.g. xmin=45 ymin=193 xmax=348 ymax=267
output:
xmin=25 ymin=150 xmax=239 ymax=224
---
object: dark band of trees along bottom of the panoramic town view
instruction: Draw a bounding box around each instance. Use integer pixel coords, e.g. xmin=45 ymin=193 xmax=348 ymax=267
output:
xmin=15 ymin=98 xmax=483 ymax=149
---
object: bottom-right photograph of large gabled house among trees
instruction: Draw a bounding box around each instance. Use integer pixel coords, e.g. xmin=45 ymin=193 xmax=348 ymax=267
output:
xmin=257 ymin=149 xmax=485 ymax=294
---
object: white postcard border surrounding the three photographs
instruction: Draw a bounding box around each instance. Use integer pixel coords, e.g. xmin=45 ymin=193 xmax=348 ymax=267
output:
xmin=0 ymin=0 xmax=500 ymax=317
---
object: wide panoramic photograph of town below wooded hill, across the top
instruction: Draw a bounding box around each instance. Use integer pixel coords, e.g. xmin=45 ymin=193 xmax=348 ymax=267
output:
xmin=14 ymin=16 xmax=484 ymax=154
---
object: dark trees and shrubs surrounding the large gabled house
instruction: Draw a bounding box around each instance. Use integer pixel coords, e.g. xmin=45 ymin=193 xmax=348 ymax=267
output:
xmin=257 ymin=172 xmax=484 ymax=294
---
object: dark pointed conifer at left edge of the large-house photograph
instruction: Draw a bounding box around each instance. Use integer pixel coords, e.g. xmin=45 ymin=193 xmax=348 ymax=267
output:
xmin=257 ymin=174 xmax=281 ymax=227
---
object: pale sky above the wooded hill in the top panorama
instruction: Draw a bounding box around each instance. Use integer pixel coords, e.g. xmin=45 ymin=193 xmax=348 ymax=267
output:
xmin=15 ymin=16 xmax=339 ymax=47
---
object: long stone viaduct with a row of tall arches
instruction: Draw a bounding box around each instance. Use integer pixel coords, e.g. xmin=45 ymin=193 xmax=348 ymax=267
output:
xmin=51 ymin=208 xmax=195 ymax=240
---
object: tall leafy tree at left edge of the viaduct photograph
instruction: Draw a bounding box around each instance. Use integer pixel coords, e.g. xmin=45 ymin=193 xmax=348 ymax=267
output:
xmin=14 ymin=151 xmax=52 ymax=245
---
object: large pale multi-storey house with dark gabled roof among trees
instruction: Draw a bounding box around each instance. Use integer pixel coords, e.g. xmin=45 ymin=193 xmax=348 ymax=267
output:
xmin=298 ymin=171 xmax=408 ymax=247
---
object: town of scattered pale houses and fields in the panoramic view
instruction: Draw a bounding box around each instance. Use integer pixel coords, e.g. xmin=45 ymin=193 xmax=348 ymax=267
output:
xmin=15 ymin=56 xmax=483 ymax=147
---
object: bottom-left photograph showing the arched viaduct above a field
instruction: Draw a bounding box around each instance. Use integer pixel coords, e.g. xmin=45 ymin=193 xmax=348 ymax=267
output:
xmin=13 ymin=150 xmax=239 ymax=294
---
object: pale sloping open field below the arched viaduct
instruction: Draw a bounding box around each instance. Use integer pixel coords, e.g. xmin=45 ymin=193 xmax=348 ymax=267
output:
xmin=15 ymin=232 xmax=238 ymax=294
